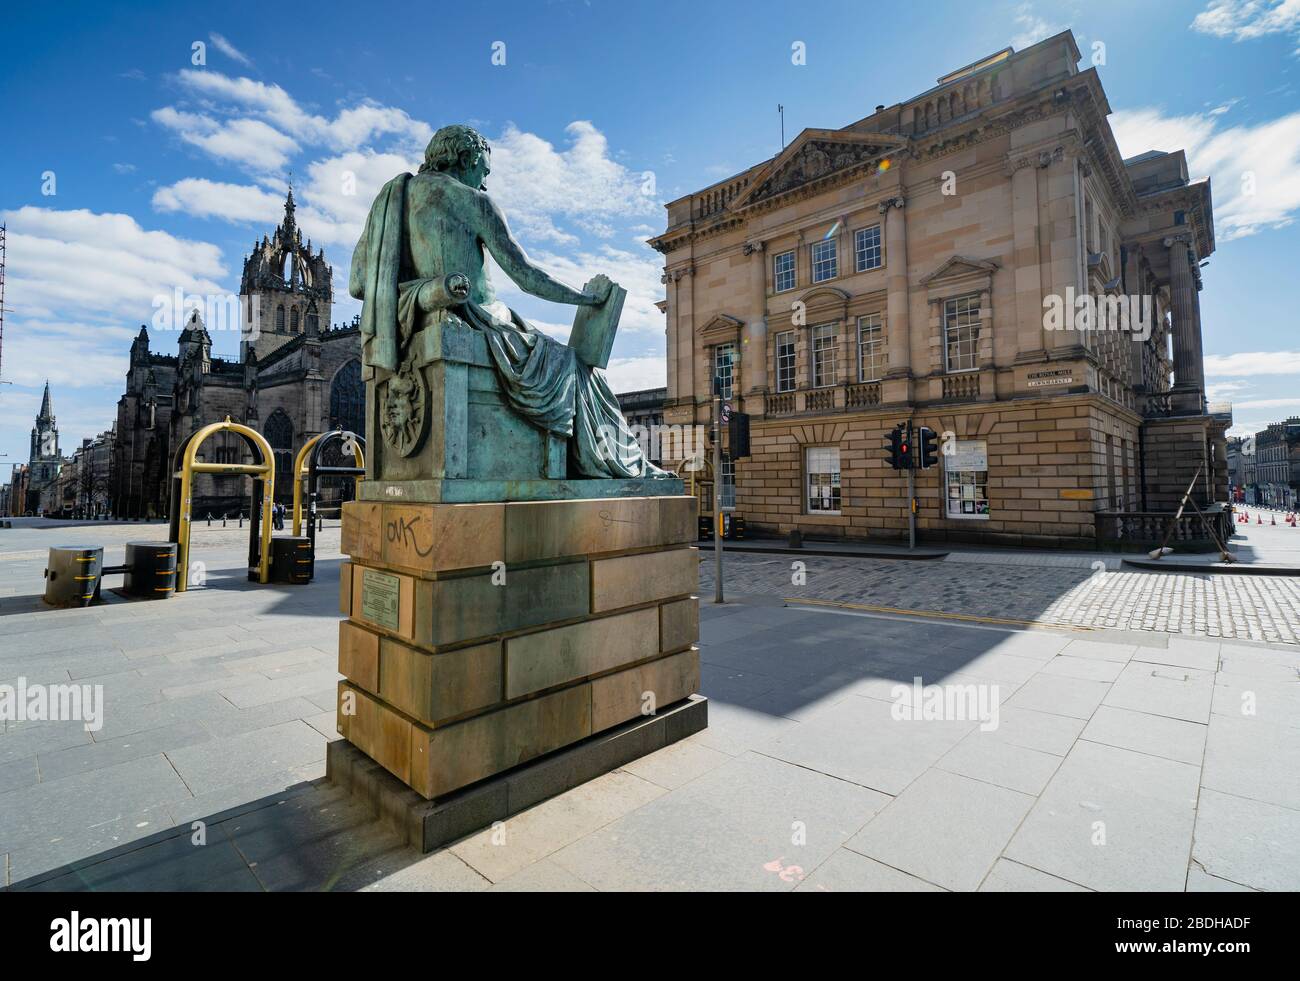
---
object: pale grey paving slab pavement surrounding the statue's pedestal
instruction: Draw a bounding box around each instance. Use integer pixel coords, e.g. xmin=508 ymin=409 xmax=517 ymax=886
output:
xmin=0 ymin=517 xmax=1300 ymax=891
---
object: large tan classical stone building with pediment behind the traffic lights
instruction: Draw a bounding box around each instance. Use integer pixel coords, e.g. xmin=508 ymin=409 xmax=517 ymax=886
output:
xmin=651 ymin=31 xmax=1229 ymax=546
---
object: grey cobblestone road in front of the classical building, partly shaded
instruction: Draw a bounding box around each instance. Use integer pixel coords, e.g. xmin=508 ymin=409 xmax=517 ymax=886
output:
xmin=699 ymin=552 xmax=1300 ymax=643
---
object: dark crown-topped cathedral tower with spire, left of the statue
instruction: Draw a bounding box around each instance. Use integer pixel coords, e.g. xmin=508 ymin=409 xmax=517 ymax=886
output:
xmin=239 ymin=187 xmax=334 ymax=361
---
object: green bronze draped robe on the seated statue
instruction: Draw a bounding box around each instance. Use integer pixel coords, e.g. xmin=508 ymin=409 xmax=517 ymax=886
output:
xmin=352 ymin=174 xmax=671 ymax=478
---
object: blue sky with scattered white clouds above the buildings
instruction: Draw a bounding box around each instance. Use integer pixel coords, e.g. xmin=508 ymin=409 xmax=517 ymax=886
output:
xmin=0 ymin=0 xmax=1300 ymax=473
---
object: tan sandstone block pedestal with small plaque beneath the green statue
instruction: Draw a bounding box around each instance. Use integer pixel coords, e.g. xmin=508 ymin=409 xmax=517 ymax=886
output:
xmin=338 ymin=493 xmax=699 ymax=799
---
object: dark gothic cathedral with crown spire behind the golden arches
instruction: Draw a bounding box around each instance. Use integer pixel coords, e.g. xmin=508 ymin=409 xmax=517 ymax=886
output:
xmin=111 ymin=188 xmax=365 ymax=520
